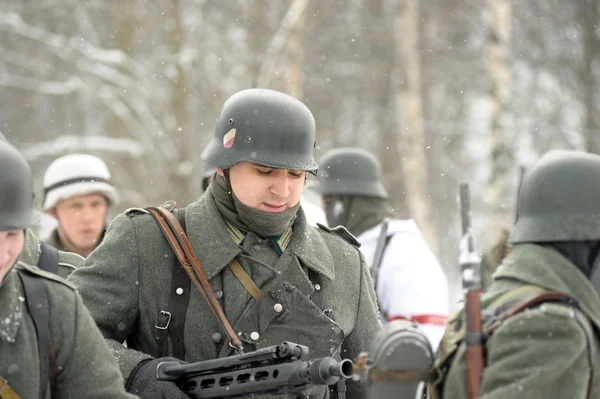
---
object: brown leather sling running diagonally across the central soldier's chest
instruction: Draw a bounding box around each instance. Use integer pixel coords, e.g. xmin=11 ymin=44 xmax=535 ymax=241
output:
xmin=147 ymin=207 xmax=243 ymax=350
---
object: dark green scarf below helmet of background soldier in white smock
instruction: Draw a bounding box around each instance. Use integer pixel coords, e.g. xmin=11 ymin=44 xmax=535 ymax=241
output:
xmin=323 ymin=195 xmax=399 ymax=237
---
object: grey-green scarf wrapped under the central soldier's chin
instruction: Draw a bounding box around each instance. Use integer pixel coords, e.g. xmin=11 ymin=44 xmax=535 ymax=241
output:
xmin=211 ymin=174 xmax=300 ymax=237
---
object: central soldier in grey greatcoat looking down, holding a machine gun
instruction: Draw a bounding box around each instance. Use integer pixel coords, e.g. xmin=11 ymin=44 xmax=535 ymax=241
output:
xmin=70 ymin=89 xmax=380 ymax=399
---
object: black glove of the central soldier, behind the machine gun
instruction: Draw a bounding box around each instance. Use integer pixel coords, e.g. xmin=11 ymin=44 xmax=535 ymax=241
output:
xmin=127 ymin=357 xmax=189 ymax=399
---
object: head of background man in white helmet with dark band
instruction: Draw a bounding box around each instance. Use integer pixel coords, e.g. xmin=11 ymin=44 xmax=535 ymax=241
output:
xmin=44 ymin=154 xmax=118 ymax=258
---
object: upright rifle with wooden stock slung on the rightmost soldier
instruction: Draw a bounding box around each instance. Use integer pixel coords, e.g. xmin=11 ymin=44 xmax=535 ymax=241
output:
xmin=460 ymin=183 xmax=485 ymax=399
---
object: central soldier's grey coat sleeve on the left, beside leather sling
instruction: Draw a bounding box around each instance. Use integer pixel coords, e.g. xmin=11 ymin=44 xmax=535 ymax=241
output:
xmin=69 ymin=215 xmax=152 ymax=380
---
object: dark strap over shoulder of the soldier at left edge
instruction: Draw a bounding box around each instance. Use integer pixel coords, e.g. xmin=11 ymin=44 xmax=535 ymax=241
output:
xmin=17 ymin=270 xmax=58 ymax=399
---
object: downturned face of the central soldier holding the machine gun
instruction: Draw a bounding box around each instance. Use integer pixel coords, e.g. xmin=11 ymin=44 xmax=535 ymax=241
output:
xmin=217 ymin=162 xmax=306 ymax=212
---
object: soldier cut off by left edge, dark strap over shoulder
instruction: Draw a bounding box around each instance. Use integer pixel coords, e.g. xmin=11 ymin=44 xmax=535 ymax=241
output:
xmin=0 ymin=140 xmax=133 ymax=399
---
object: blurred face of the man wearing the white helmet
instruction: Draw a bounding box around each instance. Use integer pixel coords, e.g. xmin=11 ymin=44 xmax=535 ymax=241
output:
xmin=53 ymin=194 xmax=108 ymax=250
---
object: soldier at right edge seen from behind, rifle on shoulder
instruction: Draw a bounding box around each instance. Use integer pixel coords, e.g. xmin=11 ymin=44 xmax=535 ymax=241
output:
xmin=430 ymin=151 xmax=600 ymax=399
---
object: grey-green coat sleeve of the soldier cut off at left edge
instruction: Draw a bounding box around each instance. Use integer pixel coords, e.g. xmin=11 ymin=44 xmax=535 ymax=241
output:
xmin=49 ymin=283 xmax=136 ymax=399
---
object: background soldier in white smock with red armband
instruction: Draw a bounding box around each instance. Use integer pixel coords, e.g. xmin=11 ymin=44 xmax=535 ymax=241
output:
xmin=317 ymin=148 xmax=449 ymax=350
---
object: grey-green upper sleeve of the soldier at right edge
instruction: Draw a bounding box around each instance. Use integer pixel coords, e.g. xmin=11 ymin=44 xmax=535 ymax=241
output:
xmin=480 ymin=303 xmax=596 ymax=399
